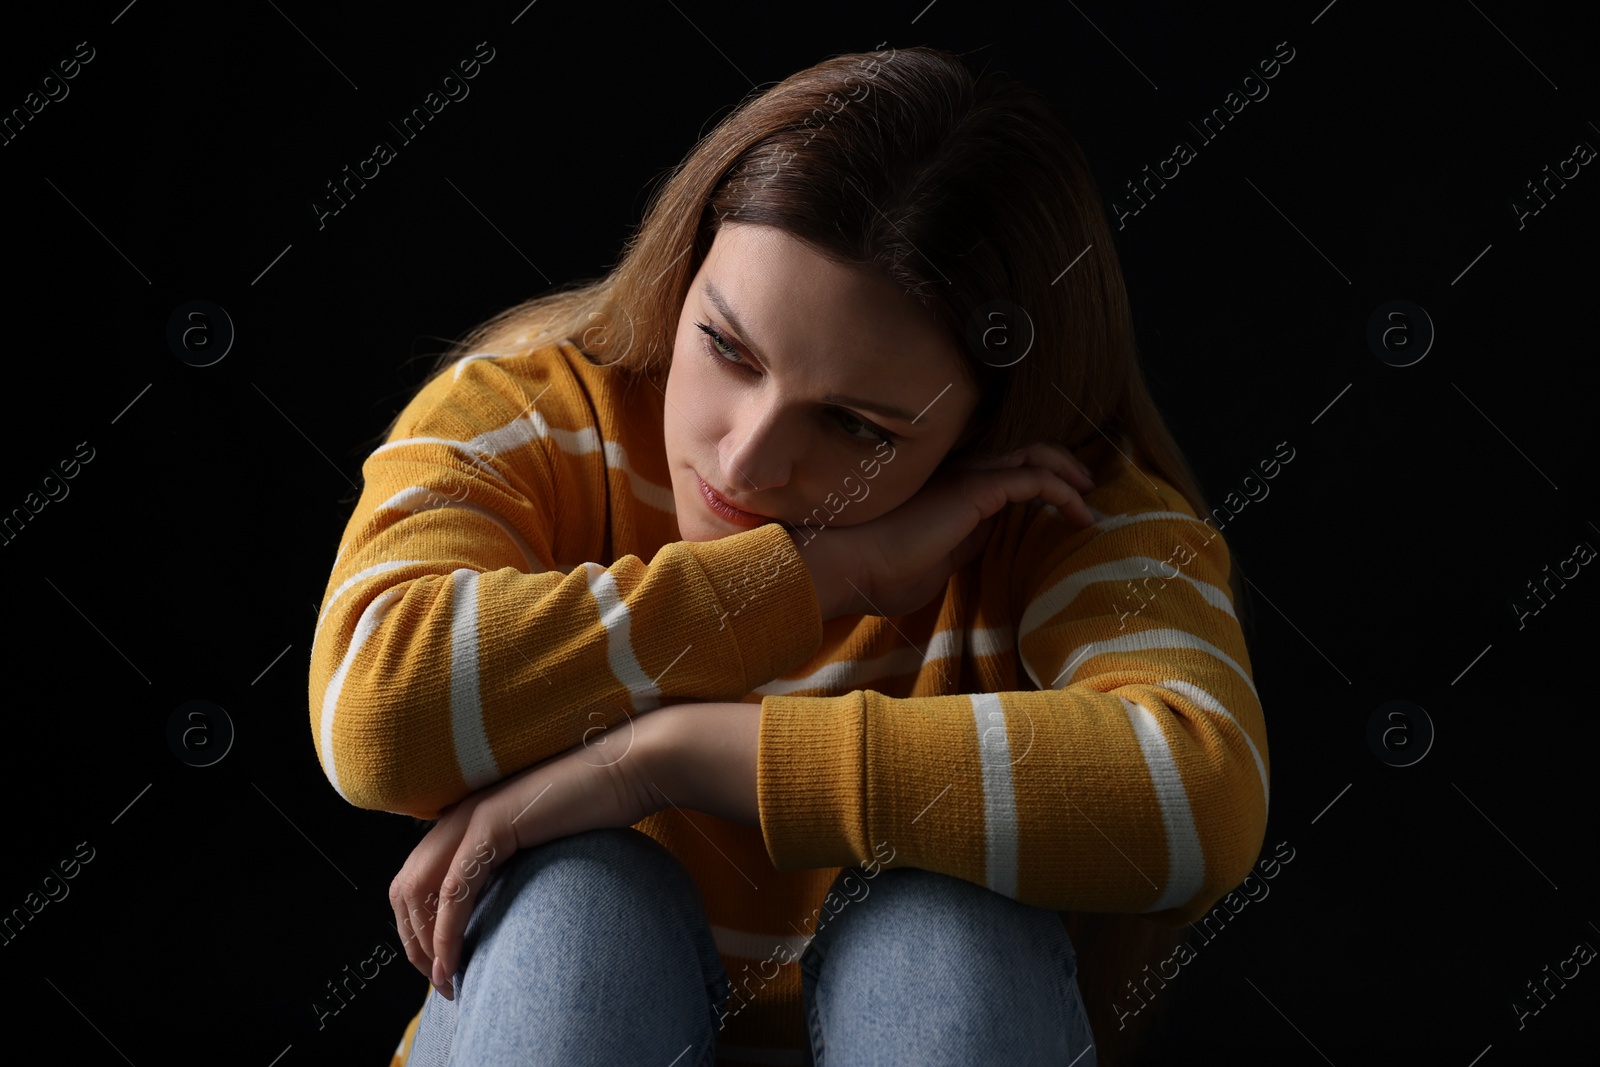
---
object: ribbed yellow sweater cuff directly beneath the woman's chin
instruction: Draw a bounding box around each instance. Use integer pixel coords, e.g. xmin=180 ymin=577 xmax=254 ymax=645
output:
xmin=678 ymin=523 xmax=822 ymax=691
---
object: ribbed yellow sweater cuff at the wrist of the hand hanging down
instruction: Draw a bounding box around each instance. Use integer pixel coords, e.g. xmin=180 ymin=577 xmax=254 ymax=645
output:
xmin=755 ymin=689 xmax=872 ymax=870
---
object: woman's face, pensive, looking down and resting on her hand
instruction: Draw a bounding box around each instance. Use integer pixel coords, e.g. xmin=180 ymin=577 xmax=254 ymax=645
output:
xmin=664 ymin=224 xmax=978 ymax=541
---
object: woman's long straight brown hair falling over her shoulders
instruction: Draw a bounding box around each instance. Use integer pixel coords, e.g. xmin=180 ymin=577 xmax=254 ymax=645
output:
xmin=386 ymin=48 xmax=1250 ymax=1067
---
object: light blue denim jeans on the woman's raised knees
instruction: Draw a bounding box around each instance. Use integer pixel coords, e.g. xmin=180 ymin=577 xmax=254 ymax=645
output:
xmin=408 ymin=829 xmax=1096 ymax=1067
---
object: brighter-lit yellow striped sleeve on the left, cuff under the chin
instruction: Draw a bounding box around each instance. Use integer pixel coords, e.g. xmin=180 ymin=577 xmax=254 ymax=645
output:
xmin=309 ymin=354 xmax=822 ymax=817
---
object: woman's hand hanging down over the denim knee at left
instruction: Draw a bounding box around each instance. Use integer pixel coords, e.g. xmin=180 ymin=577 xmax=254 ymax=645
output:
xmin=389 ymin=713 xmax=667 ymax=1000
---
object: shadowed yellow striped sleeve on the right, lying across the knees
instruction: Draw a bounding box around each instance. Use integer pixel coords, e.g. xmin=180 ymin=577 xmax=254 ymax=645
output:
xmin=758 ymin=469 xmax=1269 ymax=923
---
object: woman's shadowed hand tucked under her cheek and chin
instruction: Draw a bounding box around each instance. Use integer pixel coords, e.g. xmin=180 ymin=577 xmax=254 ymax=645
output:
xmin=806 ymin=442 xmax=1094 ymax=621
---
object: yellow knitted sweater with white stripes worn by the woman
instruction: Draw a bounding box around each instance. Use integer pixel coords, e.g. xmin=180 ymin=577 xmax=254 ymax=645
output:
xmin=310 ymin=342 xmax=1267 ymax=1067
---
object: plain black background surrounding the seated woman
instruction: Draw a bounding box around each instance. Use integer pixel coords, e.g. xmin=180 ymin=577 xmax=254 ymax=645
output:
xmin=0 ymin=0 xmax=1600 ymax=1067
